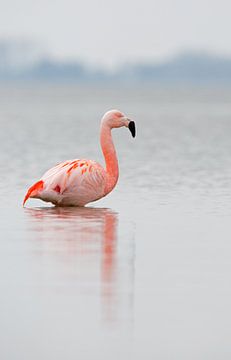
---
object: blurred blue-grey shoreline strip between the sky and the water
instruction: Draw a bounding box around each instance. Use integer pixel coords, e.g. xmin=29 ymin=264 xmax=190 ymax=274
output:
xmin=0 ymin=41 xmax=231 ymax=86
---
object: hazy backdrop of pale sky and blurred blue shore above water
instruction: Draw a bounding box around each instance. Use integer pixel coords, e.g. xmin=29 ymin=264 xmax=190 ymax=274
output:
xmin=0 ymin=0 xmax=231 ymax=82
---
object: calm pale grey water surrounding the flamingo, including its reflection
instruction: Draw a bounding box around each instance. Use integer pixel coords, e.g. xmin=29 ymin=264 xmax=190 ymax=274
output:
xmin=0 ymin=85 xmax=231 ymax=360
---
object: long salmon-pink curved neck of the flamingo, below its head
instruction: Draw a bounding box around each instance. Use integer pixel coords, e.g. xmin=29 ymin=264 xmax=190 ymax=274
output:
xmin=100 ymin=123 xmax=119 ymax=193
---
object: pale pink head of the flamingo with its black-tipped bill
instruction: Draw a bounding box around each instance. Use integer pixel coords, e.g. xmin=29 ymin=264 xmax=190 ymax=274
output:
xmin=101 ymin=110 xmax=136 ymax=137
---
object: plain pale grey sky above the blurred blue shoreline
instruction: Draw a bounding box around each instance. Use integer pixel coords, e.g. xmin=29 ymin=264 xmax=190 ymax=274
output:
xmin=0 ymin=0 xmax=231 ymax=65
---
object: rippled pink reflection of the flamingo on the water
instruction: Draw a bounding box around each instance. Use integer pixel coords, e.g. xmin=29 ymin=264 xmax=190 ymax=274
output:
xmin=25 ymin=207 xmax=133 ymax=322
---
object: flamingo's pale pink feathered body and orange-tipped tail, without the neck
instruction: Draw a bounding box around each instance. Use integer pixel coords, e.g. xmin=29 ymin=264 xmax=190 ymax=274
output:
xmin=24 ymin=159 xmax=107 ymax=206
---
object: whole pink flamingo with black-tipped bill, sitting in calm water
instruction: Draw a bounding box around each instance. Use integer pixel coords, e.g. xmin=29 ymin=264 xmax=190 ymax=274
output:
xmin=23 ymin=110 xmax=136 ymax=206
